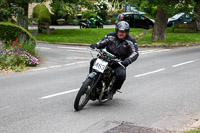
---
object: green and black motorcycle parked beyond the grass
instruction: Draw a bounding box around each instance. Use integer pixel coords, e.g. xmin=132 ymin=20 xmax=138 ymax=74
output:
xmin=80 ymin=16 xmax=103 ymax=29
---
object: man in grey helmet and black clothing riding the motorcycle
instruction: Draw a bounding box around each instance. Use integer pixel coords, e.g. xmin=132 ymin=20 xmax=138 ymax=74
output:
xmin=90 ymin=21 xmax=139 ymax=98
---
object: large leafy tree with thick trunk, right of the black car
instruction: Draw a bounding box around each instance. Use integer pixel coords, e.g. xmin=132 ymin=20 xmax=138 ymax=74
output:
xmin=130 ymin=0 xmax=195 ymax=40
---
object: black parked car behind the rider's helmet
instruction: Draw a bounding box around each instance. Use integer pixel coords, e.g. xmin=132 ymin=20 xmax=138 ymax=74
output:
xmin=116 ymin=12 xmax=154 ymax=29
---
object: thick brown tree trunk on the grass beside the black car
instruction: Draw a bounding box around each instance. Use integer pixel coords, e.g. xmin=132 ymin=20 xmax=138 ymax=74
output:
xmin=151 ymin=6 xmax=168 ymax=40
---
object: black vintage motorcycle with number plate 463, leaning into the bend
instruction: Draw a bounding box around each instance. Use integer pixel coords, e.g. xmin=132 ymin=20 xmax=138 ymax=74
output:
xmin=74 ymin=49 xmax=125 ymax=111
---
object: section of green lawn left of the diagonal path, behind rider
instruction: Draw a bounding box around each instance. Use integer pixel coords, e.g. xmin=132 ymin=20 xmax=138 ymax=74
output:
xmin=37 ymin=29 xmax=146 ymax=44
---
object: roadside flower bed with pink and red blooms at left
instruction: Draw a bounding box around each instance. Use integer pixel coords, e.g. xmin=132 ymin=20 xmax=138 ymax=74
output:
xmin=0 ymin=40 xmax=38 ymax=71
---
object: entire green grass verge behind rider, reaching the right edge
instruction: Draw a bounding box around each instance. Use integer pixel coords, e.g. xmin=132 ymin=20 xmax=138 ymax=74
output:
xmin=37 ymin=28 xmax=200 ymax=47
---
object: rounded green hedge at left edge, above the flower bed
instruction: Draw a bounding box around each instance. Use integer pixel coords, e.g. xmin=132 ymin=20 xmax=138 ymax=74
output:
xmin=0 ymin=22 xmax=36 ymax=45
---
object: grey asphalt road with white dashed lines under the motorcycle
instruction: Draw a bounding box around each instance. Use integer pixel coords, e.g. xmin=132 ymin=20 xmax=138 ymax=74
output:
xmin=0 ymin=44 xmax=200 ymax=133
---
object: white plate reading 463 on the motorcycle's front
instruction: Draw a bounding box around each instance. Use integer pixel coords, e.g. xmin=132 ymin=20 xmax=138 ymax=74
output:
xmin=92 ymin=59 xmax=108 ymax=73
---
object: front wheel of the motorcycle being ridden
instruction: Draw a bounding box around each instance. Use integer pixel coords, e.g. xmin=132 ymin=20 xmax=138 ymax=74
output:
xmin=74 ymin=78 xmax=92 ymax=111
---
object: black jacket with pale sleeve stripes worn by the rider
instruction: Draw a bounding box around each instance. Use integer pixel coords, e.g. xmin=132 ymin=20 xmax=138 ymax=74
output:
xmin=96 ymin=32 xmax=139 ymax=66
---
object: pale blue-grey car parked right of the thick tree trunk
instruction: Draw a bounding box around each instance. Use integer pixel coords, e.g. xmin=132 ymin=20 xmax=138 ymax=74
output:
xmin=167 ymin=13 xmax=192 ymax=27
